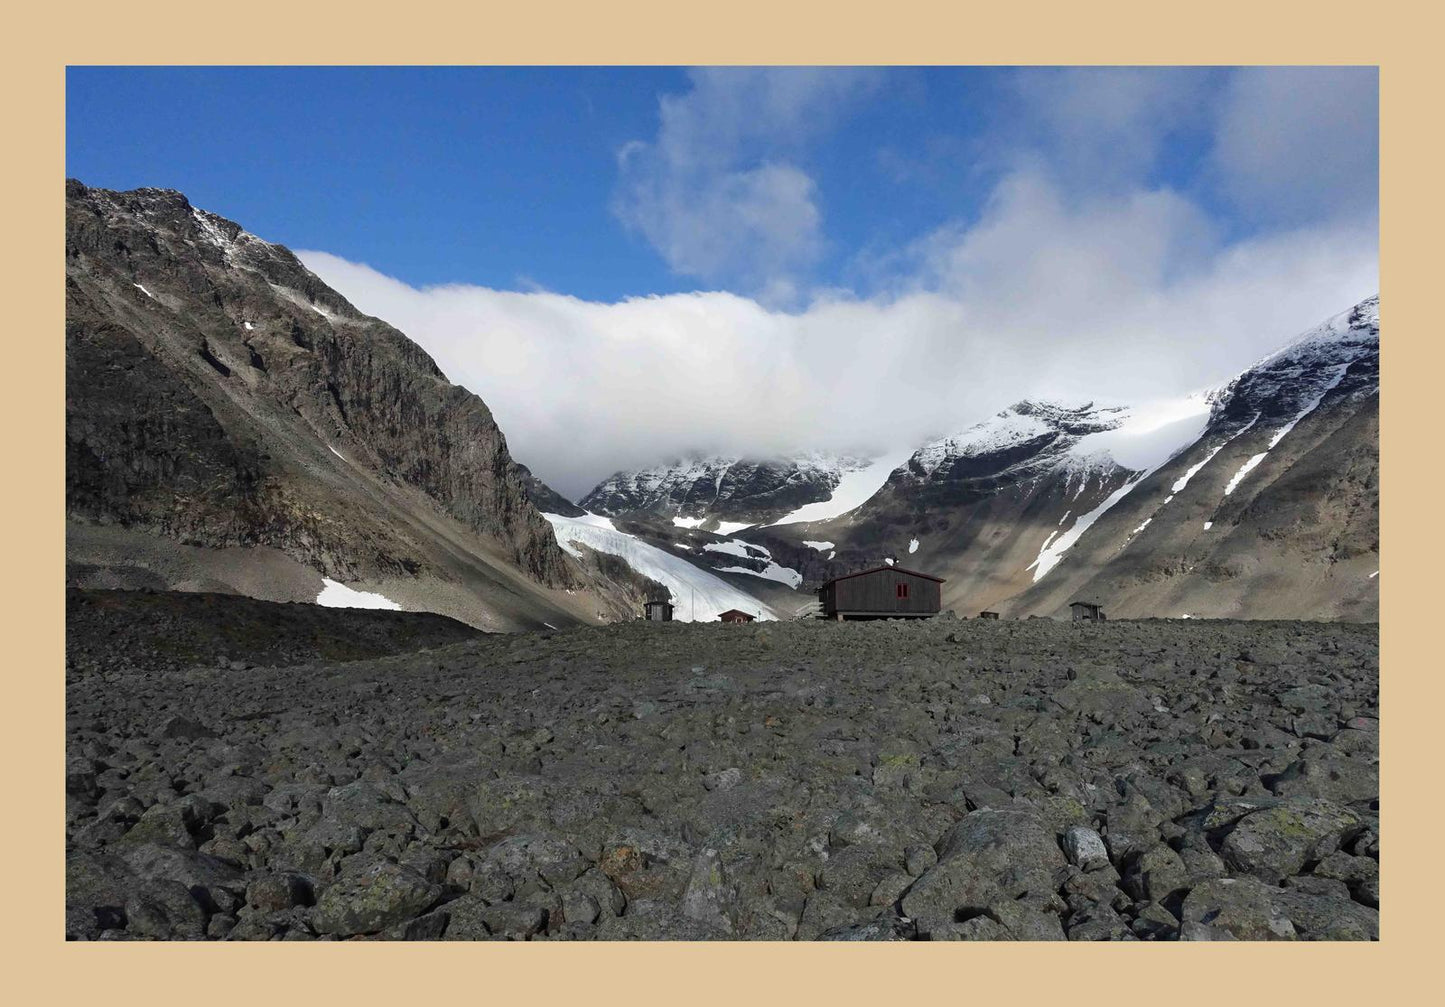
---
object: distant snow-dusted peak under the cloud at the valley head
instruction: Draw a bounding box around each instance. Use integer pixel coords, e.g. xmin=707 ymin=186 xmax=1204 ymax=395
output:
xmin=578 ymin=452 xmax=870 ymax=530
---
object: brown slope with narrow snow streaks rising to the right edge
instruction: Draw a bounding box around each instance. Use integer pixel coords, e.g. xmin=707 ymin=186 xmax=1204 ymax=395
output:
xmin=1007 ymin=296 xmax=1380 ymax=620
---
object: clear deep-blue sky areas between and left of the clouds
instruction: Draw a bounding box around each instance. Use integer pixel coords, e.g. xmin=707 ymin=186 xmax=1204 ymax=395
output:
xmin=66 ymin=68 xmax=1323 ymax=301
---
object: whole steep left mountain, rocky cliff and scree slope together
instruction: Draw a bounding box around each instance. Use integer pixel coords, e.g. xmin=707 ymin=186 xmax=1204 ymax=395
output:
xmin=65 ymin=181 xmax=649 ymax=628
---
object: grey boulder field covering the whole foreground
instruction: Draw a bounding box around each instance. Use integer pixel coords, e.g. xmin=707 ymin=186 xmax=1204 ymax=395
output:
xmin=66 ymin=595 xmax=1380 ymax=941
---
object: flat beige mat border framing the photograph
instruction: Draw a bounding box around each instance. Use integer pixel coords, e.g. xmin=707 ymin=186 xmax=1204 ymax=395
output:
xmin=0 ymin=0 xmax=1445 ymax=1007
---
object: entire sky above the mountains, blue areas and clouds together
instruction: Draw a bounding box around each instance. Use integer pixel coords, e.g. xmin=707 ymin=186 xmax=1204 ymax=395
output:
xmin=66 ymin=68 xmax=1379 ymax=488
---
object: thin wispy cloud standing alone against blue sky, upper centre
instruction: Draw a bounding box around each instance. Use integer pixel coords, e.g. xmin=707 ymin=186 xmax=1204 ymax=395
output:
xmin=613 ymin=68 xmax=876 ymax=303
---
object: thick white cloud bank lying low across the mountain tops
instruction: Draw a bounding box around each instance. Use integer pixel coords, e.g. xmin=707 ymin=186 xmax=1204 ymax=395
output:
xmin=301 ymin=179 xmax=1379 ymax=497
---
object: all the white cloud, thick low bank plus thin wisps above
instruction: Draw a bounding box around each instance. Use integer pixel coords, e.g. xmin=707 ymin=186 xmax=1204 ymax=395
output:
xmin=290 ymin=71 xmax=1379 ymax=498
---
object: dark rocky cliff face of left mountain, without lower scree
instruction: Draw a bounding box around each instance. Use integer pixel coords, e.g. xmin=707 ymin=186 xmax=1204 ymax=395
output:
xmin=65 ymin=181 xmax=574 ymax=585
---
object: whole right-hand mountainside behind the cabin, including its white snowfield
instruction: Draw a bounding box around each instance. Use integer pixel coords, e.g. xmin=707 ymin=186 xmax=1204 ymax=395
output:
xmin=741 ymin=298 xmax=1379 ymax=620
